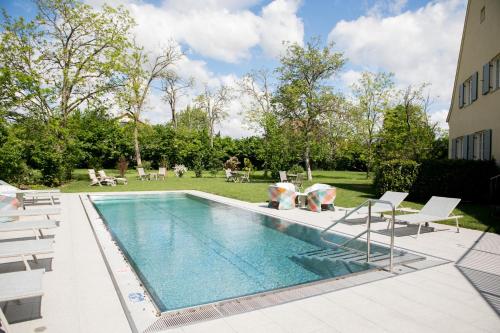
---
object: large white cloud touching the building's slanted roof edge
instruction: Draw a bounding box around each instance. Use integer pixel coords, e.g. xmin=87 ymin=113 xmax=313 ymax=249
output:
xmin=329 ymin=0 xmax=465 ymax=106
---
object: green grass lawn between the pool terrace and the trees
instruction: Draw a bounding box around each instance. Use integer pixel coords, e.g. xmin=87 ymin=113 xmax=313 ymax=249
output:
xmin=61 ymin=170 xmax=500 ymax=233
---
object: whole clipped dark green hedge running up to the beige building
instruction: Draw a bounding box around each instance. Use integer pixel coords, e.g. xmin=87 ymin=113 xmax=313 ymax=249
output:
xmin=374 ymin=160 xmax=500 ymax=203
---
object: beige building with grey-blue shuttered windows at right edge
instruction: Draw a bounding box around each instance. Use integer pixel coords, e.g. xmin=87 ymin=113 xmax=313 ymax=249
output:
xmin=447 ymin=0 xmax=500 ymax=163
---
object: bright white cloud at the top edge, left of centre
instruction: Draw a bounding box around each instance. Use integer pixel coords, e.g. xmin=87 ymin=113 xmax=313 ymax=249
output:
xmin=124 ymin=0 xmax=304 ymax=63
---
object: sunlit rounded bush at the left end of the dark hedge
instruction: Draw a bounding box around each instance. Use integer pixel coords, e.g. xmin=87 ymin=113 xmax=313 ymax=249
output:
xmin=373 ymin=160 xmax=418 ymax=195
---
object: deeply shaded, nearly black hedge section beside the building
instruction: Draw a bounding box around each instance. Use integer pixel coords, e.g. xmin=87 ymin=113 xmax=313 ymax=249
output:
xmin=410 ymin=160 xmax=499 ymax=203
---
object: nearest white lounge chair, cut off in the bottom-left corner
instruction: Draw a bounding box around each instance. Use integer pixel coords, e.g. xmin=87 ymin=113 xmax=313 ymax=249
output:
xmin=0 ymin=269 xmax=45 ymax=333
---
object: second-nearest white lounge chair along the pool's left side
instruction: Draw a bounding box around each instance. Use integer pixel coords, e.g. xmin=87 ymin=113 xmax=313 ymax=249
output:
xmin=0 ymin=239 xmax=54 ymax=271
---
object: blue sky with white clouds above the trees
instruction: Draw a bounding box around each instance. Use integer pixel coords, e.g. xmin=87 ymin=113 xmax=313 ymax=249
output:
xmin=0 ymin=0 xmax=466 ymax=136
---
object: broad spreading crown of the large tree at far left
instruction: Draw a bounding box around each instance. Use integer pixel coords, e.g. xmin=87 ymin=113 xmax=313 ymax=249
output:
xmin=1 ymin=0 xmax=133 ymax=126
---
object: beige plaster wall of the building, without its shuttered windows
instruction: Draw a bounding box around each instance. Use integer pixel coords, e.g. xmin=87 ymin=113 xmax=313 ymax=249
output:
xmin=448 ymin=0 xmax=500 ymax=163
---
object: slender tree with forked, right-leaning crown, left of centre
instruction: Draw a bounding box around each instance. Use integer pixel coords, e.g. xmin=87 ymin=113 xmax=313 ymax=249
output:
xmin=119 ymin=43 xmax=182 ymax=166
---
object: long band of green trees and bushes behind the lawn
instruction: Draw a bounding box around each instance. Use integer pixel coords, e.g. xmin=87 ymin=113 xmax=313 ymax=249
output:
xmin=0 ymin=0 xmax=447 ymax=185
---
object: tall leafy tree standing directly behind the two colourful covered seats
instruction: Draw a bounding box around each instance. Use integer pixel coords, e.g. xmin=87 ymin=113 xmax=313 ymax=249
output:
xmin=275 ymin=38 xmax=345 ymax=180
